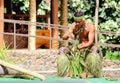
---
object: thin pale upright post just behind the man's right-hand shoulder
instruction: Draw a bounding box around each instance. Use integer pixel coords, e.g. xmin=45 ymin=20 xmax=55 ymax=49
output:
xmin=95 ymin=0 xmax=99 ymax=43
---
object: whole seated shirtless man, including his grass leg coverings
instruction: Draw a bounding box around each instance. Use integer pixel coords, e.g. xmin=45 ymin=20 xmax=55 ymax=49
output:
xmin=57 ymin=11 xmax=101 ymax=78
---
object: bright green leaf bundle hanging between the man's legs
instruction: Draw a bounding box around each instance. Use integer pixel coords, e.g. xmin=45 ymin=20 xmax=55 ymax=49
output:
xmin=67 ymin=50 xmax=85 ymax=77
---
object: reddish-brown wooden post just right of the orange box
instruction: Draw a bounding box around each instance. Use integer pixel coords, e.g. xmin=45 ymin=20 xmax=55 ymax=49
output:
xmin=51 ymin=0 xmax=58 ymax=49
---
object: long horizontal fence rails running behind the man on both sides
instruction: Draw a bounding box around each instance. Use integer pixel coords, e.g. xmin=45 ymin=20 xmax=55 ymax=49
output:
xmin=0 ymin=19 xmax=120 ymax=48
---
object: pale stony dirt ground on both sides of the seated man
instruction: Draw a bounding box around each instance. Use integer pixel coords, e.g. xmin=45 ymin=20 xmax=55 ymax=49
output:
xmin=9 ymin=49 xmax=120 ymax=77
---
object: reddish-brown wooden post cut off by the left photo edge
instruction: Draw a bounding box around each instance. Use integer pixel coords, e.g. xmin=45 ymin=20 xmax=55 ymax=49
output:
xmin=0 ymin=0 xmax=4 ymax=47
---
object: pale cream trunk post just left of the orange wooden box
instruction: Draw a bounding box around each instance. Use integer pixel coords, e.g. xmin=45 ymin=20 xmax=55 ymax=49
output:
xmin=28 ymin=0 xmax=36 ymax=50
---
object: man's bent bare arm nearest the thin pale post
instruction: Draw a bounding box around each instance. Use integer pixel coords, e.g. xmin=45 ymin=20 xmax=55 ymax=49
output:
xmin=78 ymin=25 xmax=95 ymax=49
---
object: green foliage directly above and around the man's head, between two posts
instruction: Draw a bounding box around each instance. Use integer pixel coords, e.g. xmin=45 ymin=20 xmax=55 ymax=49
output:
xmin=68 ymin=0 xmax=95 ymax=23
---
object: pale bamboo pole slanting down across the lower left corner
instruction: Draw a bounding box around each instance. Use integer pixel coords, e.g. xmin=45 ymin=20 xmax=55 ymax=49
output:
xmin=0 ymin=60 xmax=45 ymax=80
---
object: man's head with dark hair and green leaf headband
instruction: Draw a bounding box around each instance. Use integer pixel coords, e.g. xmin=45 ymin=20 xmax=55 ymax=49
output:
xmin=73 ymin=11 xmax=84 ymax=25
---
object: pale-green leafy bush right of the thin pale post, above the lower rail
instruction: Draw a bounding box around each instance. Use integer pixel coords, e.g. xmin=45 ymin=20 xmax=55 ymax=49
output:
xmin=99 ymin=0 xmax=120 ymax=44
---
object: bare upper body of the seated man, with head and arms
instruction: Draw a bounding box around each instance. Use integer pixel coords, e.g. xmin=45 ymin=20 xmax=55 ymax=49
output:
xmin=62 ymin=11 xmax=95 ymax=50
